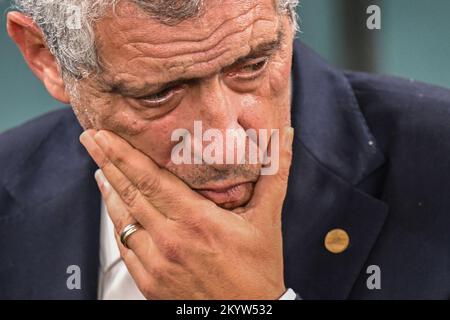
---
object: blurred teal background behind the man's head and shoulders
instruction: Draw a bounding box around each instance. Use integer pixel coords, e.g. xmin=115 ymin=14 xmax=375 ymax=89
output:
xmin=0 ymin=0 xmax=450 ymax=132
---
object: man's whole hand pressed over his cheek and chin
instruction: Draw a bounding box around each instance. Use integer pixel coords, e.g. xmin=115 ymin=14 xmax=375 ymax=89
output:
xmin=80 ymin=128 xmax=293 ymax=299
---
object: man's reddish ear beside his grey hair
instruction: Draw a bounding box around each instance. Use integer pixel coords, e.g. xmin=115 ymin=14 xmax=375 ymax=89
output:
xmin=6 ymin=12 xmax=70 ymax=104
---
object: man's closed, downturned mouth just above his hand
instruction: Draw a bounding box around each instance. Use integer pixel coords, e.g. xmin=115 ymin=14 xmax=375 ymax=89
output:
xmin=195 ymin=182 xmax=253 ymax=208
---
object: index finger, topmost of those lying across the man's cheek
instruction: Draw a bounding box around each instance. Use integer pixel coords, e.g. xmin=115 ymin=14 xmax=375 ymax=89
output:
xmin=95 ymin=131 xmax=211 ymax=219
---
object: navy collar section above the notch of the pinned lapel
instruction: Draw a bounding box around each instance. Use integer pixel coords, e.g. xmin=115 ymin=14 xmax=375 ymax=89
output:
xmin=292 ymin=42 xmax=384 ymax=185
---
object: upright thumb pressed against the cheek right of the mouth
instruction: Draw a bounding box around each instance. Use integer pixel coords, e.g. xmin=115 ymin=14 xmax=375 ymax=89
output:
xmin=246 ymin=127 xmax=294 ymax=223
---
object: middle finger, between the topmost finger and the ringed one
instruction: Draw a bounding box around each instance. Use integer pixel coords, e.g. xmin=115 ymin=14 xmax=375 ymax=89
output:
xmin=80 ymin=130 xmax=165 ymax=233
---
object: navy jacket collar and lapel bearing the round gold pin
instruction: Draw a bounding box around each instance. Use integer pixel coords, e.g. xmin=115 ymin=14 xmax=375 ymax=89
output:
xmin=283 ymin=43 xmax=388 ymax=299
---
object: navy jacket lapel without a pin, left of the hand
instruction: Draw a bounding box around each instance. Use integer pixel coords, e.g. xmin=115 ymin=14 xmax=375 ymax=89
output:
xmin=0 ymin=110 xmax=100 ymax=299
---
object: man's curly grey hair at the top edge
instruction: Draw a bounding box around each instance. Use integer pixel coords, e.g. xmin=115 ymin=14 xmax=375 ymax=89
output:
xmin=13 ymin=0 xmax=298 ymax=80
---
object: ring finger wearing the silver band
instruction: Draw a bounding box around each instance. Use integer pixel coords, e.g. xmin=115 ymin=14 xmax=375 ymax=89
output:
xmin=95 ymin=170 xmax=154 ymax=262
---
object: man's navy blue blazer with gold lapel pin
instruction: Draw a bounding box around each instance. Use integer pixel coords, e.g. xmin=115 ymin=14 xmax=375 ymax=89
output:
xmin=0 ymin=42 xmax=450 ymax=299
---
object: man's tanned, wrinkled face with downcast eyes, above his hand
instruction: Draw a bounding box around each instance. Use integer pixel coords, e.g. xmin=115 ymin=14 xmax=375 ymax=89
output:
xmin=73 ymin=0 xmax=293 ymax=209
